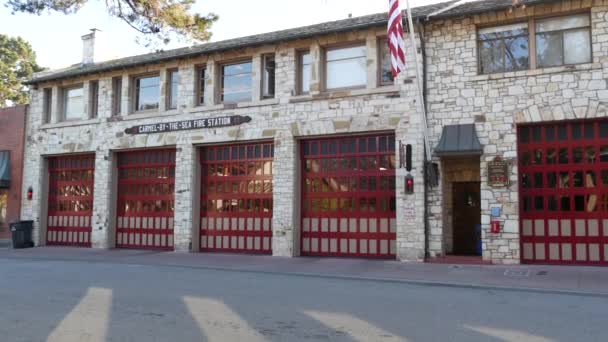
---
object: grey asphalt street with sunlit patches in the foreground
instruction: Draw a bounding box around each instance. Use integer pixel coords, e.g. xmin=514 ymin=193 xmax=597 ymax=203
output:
xmin=0 ymin=258 xmax=608 ymax=342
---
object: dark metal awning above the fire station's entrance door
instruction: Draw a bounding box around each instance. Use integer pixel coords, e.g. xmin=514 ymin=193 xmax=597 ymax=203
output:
xmin=435 ymin=124 xmax=483 ymax=157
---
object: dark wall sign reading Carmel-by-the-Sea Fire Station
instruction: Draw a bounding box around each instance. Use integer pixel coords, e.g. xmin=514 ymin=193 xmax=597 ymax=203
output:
xmin=125 ymin=115 xmax=251 ymax=134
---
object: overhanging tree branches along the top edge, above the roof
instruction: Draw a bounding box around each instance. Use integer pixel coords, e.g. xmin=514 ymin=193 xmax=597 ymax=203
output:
xmin=6 ymin=0 xmax=218 ymax=44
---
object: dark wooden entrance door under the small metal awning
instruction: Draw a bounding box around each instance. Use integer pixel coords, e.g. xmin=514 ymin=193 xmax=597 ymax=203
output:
xmin=452 ymin=182 xmax=481 ymax=255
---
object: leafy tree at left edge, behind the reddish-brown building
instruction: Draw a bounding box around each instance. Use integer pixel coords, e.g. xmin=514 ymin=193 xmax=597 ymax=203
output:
xmin=0 ymin=34 xmax=42 ymax=108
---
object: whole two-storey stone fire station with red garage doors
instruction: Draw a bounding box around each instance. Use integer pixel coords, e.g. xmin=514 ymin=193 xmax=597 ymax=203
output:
xmin=22 ymin=0 xmax=608 ymax=265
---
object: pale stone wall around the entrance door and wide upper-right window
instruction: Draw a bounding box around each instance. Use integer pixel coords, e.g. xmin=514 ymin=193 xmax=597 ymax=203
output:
xmin=426 ymin=0 xmax=608 ymax=263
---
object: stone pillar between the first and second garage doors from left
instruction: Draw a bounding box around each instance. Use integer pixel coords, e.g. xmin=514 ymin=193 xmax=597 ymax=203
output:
xmin=91 ymin=150 xmax=117 ymax=248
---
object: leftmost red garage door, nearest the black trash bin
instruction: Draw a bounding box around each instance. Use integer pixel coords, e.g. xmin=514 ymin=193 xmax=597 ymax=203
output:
xmin=46 ymin=154 xmax=95 ymax=247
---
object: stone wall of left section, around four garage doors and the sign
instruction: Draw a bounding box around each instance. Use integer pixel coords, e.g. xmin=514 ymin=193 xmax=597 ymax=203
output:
xmin=22 ymin=28 xmax=424 ymax=260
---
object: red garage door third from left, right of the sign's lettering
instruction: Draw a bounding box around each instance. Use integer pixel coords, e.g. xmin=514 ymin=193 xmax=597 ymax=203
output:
xmin=200 ymin=143 xmax=274 ymax=254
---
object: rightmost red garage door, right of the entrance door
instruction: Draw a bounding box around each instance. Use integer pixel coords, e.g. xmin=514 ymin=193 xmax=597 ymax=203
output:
xmin=518 ymin=119 xmax=608 ymax=265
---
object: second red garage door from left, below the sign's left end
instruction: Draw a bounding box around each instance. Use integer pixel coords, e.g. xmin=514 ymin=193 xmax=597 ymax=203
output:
xmin=116 ymin=149 xmax=175 ymax=250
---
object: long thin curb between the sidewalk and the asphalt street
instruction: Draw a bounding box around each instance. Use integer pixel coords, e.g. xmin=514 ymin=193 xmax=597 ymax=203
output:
xmin=0 ymin=256 xmax=608 ymax=298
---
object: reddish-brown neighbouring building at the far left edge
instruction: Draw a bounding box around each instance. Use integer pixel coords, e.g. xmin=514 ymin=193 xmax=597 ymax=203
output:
xmin=0 ymin=106 xmax=27 ymax=240
